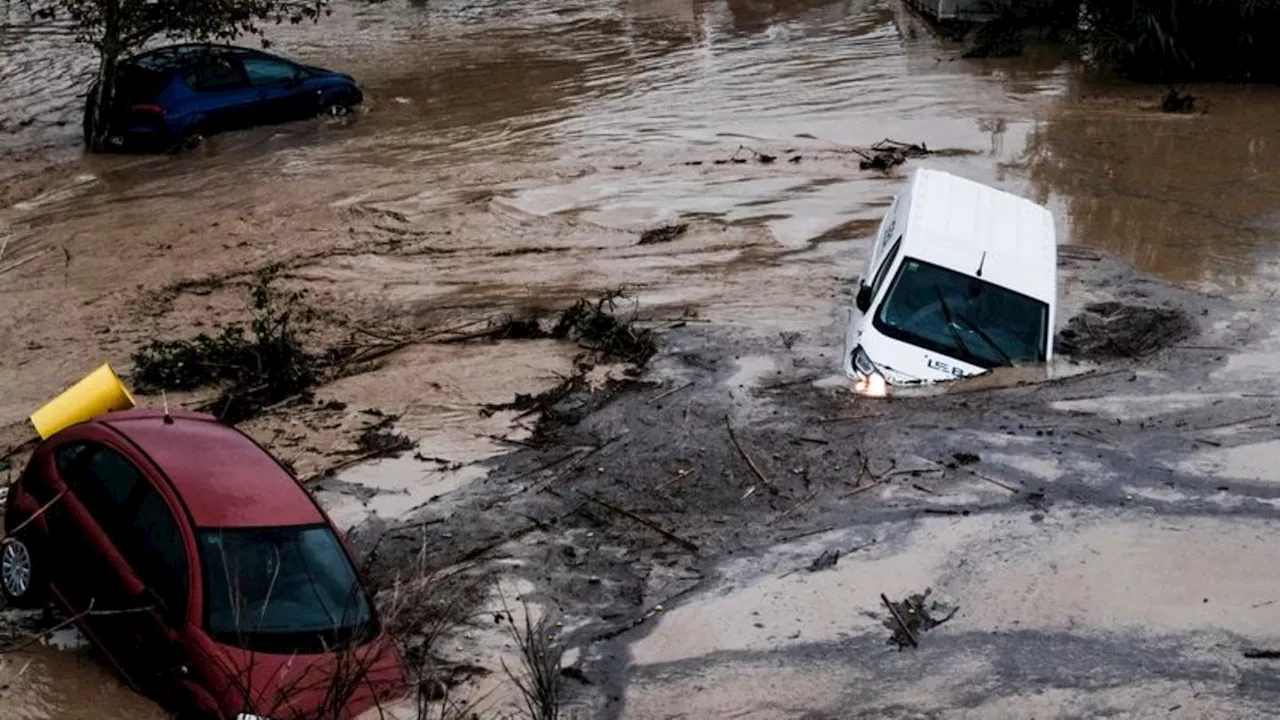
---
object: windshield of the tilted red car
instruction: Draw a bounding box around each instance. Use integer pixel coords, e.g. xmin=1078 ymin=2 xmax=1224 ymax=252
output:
xmin=198 ymin=525 xmax=376 ymax=653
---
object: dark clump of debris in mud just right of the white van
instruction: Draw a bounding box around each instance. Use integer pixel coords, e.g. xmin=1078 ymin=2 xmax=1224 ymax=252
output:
xmin=1057 ymin=301 xmax=1196 ymax=360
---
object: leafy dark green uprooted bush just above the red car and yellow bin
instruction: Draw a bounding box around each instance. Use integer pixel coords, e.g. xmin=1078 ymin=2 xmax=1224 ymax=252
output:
xmin=133 ymin=269 xmax=325 ymax=423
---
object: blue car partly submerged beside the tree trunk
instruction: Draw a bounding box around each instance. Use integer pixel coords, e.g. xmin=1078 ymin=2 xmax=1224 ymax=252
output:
xmin=84 ymin=45 xmax=364 ymax=150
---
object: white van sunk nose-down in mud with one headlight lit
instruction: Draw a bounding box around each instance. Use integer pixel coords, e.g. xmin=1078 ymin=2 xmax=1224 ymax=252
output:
xmin=845 ymin=169 xmax=1057 ymax=395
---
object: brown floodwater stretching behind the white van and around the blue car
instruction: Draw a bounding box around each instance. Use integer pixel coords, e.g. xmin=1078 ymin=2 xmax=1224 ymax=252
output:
xmin=0 ymin=0 xmax=1280 ymax=720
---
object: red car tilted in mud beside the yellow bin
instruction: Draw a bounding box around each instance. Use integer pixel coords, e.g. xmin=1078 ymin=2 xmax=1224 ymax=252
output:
xmin=0 ymin=410 xmax=406 ymax=720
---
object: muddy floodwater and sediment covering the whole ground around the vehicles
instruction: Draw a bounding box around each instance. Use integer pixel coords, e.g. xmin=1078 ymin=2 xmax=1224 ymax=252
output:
xmin=0 ymin=0 xmax=1280 ymax=717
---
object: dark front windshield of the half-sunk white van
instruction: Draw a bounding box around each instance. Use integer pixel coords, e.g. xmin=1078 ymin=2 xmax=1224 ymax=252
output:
xmin=873 ymin=258 xmax=1048 ymax=369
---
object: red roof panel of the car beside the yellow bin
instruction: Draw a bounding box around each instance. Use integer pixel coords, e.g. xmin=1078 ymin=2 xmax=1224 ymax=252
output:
xmin=97 ymin=410 xmax=325 ymax=528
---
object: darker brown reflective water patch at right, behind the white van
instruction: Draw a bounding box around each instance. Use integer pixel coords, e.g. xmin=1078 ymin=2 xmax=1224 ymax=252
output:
xmin=1025 ymin=78 xmax=1280 ymax=288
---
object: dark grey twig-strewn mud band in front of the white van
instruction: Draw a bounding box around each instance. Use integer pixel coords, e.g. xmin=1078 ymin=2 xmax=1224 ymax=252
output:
xmin=371 ymin=292 xmax=1280 ymax=717
